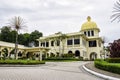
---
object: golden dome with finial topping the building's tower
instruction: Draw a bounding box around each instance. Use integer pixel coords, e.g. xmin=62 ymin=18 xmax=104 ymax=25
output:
xmin=81 ymin=16 xmax=99 ymax=31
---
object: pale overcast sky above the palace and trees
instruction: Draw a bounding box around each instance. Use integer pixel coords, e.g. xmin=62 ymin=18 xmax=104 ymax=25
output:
xmin=0 ymin=0 xmax=120 ymax=43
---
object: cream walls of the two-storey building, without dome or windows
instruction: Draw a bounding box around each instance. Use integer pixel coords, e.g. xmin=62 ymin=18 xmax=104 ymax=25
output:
xmin=40 ymin=29 xmax=103 ymax=59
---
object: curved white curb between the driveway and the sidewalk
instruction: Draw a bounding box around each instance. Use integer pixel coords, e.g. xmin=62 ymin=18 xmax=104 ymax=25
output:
xmin=82 ymin=65 xmax=120 ymax=80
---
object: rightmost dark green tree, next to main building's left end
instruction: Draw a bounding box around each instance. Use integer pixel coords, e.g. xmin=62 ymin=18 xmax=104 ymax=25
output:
xmin=30 ymin=30 xmax=43 ymax=46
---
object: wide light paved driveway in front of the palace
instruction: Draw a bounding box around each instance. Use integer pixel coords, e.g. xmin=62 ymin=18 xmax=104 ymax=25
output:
xmin=0 ymin=61 xmax=103 ymax=80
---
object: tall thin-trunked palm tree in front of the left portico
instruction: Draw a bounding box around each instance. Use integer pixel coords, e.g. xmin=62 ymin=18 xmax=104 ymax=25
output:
xmin=9 ymin=16 xmax=26 ymax=59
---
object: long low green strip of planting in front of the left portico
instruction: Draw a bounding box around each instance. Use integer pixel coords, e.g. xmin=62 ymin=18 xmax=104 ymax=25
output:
xmin=0 ymin=60 xmax=45 ymax=65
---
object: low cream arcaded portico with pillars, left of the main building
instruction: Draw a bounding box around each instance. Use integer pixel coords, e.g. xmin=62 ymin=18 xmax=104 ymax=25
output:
xmin=0 ymin=41 xmax=49 ymax=61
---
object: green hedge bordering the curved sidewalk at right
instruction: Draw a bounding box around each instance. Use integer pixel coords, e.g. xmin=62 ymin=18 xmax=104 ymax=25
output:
xmin=94 ymin=60 xmax=120 ymax=74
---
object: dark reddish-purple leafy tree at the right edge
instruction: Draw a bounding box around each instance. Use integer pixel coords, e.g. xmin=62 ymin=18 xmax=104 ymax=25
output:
xmin=109 ymin=39 xmax=120 ymax=58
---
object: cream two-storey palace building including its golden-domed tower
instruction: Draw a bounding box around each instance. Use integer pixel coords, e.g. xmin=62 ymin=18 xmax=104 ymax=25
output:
xmin=37 ymin=16 xmax=103 ymax=60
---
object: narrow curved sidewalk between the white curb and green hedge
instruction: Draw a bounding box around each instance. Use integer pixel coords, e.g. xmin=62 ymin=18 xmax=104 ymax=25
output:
xmin=85 ymin=62 xmax=120 ymax=78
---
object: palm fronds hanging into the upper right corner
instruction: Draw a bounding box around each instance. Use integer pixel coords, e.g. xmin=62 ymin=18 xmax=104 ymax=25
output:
xmin=110 ymin=0 xmax=120 ymax=22
